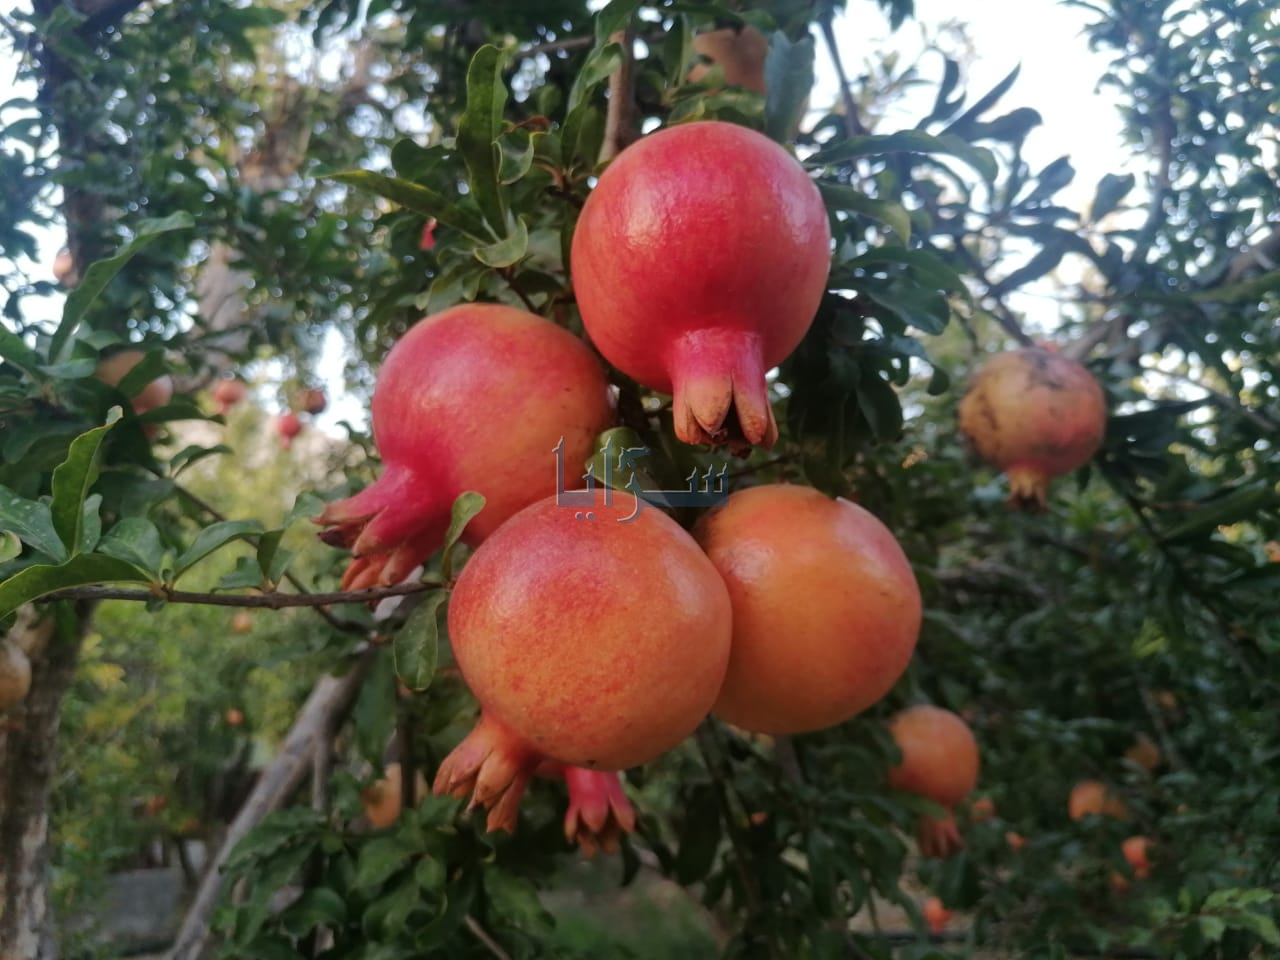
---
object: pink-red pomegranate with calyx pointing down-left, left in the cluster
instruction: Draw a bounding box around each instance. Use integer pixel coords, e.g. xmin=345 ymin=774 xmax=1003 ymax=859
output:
xmin=309 ymin=303 xmax=612 ymax=590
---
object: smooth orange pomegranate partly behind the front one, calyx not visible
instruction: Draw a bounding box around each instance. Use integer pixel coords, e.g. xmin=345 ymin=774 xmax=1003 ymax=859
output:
xmin=694 ymin=484 xmax=922 ymax=735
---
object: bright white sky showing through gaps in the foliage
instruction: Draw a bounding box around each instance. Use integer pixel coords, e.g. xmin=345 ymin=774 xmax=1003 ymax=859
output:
xmin=0 ymin=0 xmax=1140 ymax=431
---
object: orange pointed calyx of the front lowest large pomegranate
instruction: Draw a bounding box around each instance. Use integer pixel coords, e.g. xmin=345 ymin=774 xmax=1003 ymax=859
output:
xmin=431 ymin=713 xmax=541 ymax=833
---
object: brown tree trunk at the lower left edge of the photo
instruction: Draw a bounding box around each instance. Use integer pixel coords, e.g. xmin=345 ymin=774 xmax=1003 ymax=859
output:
xmin=0 ymin=604 xmax=90 ymax=960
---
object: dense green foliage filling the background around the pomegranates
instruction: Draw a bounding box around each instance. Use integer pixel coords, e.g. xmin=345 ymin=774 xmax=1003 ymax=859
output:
xmin=0 ymin=0 xmax=1280 ymax=960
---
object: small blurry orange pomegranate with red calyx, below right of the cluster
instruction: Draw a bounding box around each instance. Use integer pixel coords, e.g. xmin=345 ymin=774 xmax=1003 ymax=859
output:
xmin=888 ymin=704 xmax=979 ymax=858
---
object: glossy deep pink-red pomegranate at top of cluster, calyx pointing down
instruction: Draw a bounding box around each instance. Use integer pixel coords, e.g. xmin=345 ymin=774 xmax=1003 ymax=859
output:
xmin=571 ymin=120 xmax=831 ymax=447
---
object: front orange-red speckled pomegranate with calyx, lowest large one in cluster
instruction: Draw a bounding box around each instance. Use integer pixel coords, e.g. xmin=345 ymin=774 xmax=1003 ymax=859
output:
xmin=435 ymin=493 xmax=732 ymax=829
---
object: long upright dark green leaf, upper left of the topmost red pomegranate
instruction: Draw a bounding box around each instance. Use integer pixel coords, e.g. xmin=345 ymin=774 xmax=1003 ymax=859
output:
xmin=458 ymin=44 xmax=507 ymax=237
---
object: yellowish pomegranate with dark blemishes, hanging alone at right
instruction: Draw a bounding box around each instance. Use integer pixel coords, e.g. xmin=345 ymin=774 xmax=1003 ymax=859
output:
xmin=960 ymin=347 xmax=1107 ymax=509
